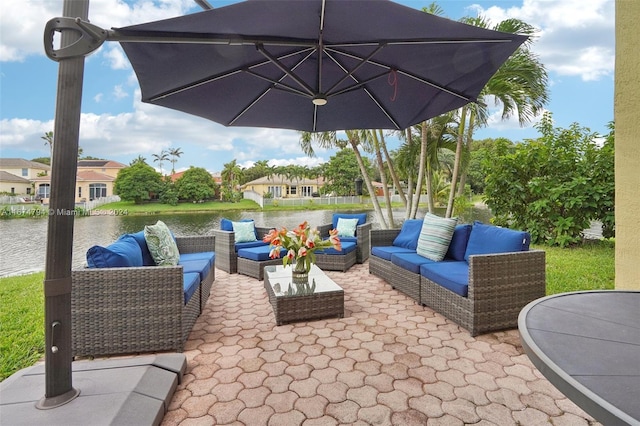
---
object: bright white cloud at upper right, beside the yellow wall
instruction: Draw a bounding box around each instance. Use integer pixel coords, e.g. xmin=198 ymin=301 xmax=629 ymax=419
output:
xmin=472 ymin=0 xmax=615 ymax=81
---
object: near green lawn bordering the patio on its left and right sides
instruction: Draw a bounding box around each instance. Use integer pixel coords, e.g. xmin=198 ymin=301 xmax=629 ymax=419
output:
xmin=0 ymin=238 xmax=614 ymax=380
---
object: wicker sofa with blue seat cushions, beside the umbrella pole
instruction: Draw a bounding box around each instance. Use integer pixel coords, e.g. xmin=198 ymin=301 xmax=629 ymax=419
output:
xmin=71 ymin=231 xmax=216 ymax=356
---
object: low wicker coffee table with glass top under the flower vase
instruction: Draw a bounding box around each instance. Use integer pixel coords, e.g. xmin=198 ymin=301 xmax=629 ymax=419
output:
xmin=264 ymin=265 xmax=344 ymax=325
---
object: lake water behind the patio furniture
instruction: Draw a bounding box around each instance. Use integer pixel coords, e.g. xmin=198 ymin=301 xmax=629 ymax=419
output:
xmin=0 ymin=209 xmax=490 ymax=277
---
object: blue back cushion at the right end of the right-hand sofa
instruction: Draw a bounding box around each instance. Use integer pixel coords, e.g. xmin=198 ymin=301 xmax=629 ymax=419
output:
xmin=464 ymin=222 xmax=531 ymax=262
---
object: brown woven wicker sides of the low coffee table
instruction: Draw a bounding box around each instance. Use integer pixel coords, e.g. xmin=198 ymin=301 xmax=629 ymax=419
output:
xmin=264 ymin=277 xmax=344 ymax=325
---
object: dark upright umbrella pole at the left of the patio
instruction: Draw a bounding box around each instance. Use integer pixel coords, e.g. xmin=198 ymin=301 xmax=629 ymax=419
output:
xmin=36 ymin=0 xmax=89 ymax=409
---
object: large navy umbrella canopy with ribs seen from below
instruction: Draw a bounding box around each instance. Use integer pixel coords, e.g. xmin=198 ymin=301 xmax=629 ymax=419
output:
xmin=115 ymin=0 xmax=526 ymax=132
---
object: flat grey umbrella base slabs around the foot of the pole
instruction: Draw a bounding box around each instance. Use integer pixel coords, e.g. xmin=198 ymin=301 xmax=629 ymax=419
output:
xmin=0 ymin=353 xmax=187 ymax=425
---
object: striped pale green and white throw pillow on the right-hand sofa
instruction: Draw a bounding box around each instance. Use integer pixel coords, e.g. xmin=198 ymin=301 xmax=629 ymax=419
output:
xmin=416 ymin=213 xmax=458 ymax=262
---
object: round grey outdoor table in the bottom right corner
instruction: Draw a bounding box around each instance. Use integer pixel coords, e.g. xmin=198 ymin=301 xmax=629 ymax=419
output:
xmin=518 ymin=290 xmax=640 ymax=425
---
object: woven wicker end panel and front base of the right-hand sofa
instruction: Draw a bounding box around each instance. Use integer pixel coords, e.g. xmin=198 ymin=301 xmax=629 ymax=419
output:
xmin=420 ymin=250 xmax=546 ymax=336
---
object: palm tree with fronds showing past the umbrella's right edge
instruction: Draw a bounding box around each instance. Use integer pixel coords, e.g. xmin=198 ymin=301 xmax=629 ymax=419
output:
xmin=445 ymin=17 xmax=549 ymax=217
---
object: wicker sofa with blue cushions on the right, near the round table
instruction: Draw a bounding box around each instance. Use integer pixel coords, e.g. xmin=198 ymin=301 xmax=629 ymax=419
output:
xmin=369 ymin=220 xmax=546 ymax=336
